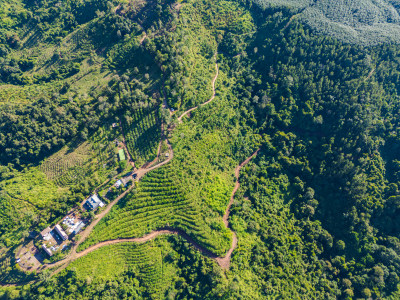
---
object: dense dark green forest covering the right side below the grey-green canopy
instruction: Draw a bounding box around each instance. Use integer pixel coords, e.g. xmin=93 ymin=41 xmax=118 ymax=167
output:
xmin=212 ymin=7 xmax=399 ymax=299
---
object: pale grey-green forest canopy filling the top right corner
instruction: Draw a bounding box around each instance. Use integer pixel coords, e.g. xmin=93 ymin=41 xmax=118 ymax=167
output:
xmin=253 ymin=0 xmax=400 ymax=45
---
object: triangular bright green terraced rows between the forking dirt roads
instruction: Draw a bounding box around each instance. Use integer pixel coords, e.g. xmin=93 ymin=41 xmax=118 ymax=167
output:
xmin=79 ymin=165 xmax=229 ymax=254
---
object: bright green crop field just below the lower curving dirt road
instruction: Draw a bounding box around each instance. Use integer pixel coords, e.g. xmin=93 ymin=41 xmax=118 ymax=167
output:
xmin=69 ymin=237 xmax=174 ymax=299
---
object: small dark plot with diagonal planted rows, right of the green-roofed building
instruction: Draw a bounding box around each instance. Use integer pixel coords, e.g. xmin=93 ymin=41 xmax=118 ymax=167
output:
xmin=123 ymin=108 xmax=161 ymax=166
